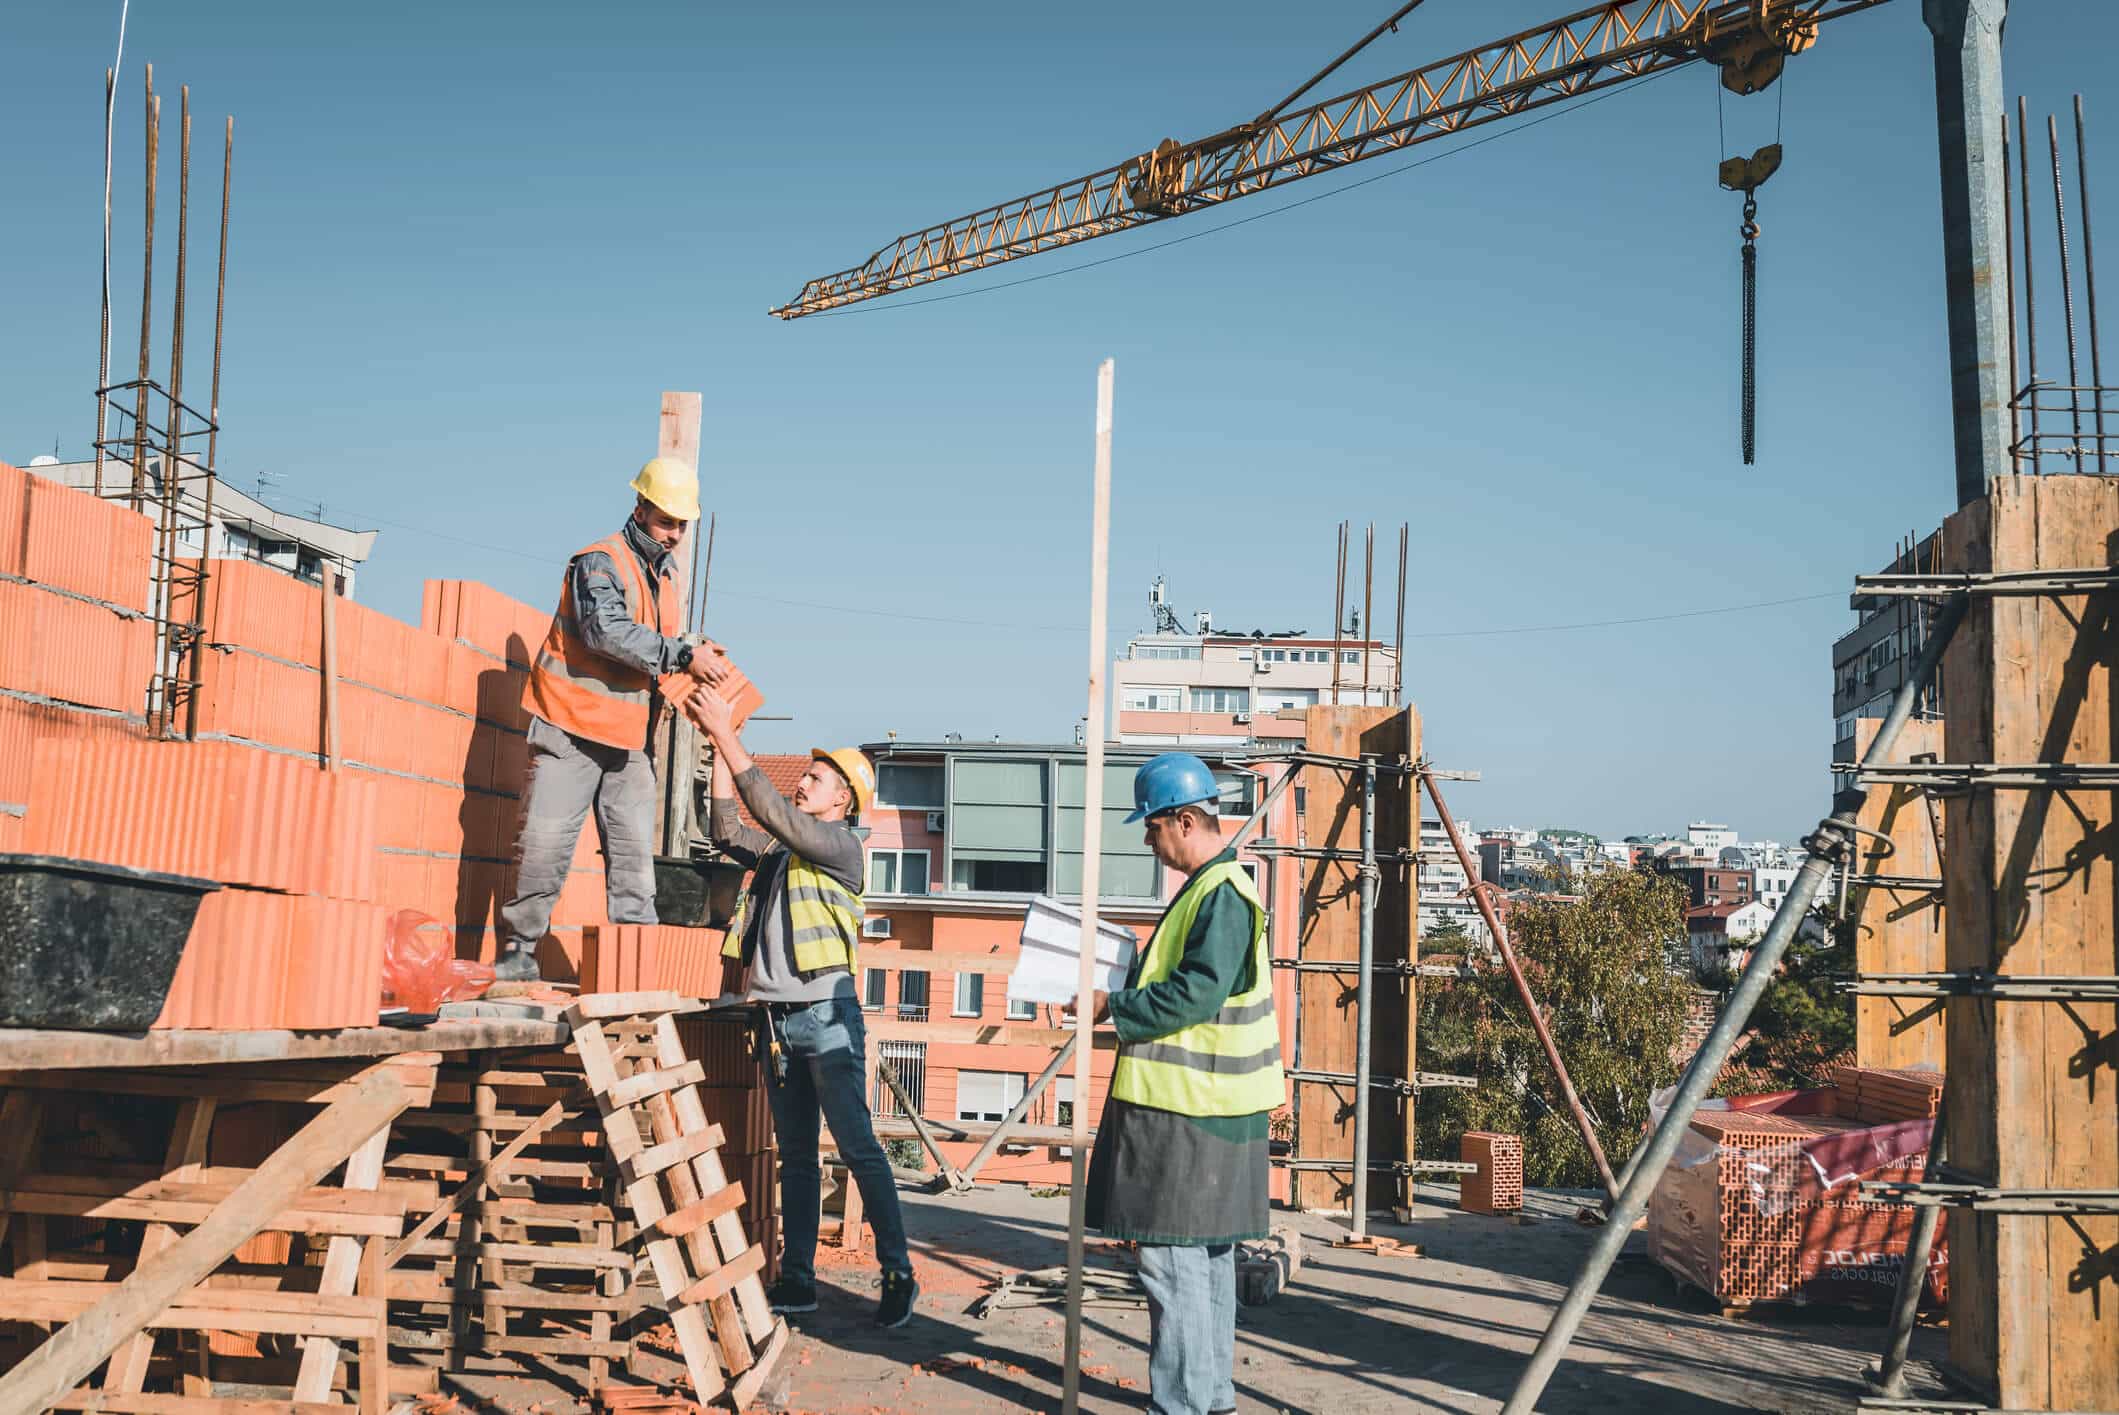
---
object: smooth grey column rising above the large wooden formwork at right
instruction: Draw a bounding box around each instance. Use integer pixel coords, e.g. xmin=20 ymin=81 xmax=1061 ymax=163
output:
xmin=1922 ymin=0 xmax=2015 ymax=506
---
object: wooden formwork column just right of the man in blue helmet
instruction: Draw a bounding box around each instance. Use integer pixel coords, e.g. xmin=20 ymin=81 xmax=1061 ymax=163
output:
xmin=1288 ymin=708 xmax=1420 ymax=1210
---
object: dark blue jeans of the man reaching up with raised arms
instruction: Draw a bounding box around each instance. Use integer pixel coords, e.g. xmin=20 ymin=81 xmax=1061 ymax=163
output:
xmin=765 ymin=998 xmax=911 ymax=1292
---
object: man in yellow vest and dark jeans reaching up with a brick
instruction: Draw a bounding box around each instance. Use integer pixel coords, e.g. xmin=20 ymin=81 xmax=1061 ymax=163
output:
xmin=687 ymin=686 xmax=920 ymax=1326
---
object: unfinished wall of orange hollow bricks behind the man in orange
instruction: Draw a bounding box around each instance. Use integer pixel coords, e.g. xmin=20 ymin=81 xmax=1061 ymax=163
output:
xmin=0 ymin=464 xmax=720 ymax=1027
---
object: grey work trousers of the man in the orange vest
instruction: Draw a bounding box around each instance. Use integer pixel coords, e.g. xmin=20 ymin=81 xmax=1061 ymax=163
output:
xmin=500 ymin=716 xmax=657 ymax=953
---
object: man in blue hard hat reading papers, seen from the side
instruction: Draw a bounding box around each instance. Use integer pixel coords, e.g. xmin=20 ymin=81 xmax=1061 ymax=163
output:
xmin=1087 ymin=752 xmax=1286 ymax=1415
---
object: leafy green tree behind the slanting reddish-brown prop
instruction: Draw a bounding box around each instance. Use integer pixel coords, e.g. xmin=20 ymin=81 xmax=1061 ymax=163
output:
xmin=1418 ymin=871 xmax=1691 ymax=1188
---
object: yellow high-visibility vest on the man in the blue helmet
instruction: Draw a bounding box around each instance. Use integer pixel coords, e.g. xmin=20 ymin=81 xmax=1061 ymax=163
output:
xmin=1110 ymin=860 xmax=1288 ymax=1116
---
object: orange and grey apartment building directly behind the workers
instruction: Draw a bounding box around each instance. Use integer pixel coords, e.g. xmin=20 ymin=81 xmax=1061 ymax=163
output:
xmin=858 ymin=741 xmax=1299 ymax=1184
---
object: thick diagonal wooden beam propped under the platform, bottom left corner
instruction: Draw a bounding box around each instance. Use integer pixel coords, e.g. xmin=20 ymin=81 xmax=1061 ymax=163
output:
xmin=0 ymin=1065 xmax=413 ymax=1411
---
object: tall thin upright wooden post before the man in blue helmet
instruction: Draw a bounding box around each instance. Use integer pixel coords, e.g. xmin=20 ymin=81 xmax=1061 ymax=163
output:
xmin=1062 ymin=358 xmax=1115 ymax=1415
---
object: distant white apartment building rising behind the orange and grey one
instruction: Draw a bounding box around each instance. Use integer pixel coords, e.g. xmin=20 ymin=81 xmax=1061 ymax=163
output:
xmin=1110 ymin=580 xmax=1399 ymax=748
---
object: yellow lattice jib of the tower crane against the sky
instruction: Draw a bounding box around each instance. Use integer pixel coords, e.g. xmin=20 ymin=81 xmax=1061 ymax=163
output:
xmin=771 ymin=0 xmax=1886 ymax=320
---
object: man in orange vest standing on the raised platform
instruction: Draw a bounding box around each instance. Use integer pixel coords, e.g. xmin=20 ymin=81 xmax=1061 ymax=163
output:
xmin=494 ymin=458 xmax=725 ymax=983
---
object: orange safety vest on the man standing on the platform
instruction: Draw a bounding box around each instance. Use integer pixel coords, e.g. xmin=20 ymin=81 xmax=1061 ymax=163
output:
xmin=523 ymin=532 xmax=678 ymax=752
